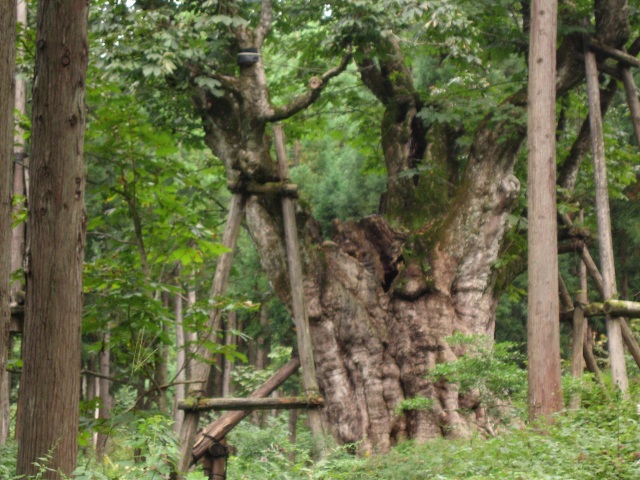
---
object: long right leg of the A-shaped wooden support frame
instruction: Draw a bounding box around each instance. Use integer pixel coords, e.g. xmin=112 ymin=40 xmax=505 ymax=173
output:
xmin=273 ymin=125 xmax=325 ymax=456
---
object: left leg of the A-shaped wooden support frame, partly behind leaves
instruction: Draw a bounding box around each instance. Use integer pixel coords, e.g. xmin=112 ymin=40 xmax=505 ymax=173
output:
xmin=180 ymin=193 xmax=250 ymax=472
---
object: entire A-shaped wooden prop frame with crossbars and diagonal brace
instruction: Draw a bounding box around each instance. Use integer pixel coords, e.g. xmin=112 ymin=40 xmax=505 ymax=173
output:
xmin=179 ymin=125 xmax=325 ymax=479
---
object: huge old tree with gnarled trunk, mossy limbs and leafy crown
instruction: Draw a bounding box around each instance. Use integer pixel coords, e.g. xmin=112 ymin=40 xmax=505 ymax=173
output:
xmin=124 ymin=0 xmax=630 ymax=451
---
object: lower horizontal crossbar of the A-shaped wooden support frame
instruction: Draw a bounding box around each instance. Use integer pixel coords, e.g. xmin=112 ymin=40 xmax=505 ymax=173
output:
xmin=178 ymin=397 xmax=324 ymax=412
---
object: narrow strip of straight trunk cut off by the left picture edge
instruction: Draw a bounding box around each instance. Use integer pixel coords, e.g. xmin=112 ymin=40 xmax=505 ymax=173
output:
xmin=0 ymin=1 xmax=16 ymax=444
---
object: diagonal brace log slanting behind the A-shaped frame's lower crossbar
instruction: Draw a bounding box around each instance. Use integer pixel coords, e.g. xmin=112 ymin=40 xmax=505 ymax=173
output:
xmin=191 ymin=358 xmax=300 ymax=464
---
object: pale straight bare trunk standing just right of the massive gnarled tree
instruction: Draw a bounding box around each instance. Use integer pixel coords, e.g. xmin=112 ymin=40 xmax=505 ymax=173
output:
xmin=527 ymin=0 xmax=563 ymax=419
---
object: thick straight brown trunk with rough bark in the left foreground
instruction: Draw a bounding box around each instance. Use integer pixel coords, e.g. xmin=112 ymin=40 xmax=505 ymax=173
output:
xmin=17 ymin=0 xmax=88 ymax=479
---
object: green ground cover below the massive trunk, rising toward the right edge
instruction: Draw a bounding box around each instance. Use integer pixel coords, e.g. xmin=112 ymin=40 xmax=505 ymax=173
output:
xmin=228 ymin=392 xmax=640 ymax=480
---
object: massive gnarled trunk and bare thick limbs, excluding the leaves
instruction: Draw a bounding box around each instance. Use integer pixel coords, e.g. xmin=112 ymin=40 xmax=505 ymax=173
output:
xmin=190 ymin=1 xmax=626 ymax=451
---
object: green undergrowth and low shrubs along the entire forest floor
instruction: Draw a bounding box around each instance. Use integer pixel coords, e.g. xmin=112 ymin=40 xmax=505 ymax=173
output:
xmin=0 ymin=344 xmax=640 ymax=480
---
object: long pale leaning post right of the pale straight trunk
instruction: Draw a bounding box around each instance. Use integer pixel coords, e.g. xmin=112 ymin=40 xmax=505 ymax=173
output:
xmin=584 ymin=40 xmax=629 ymax=396
